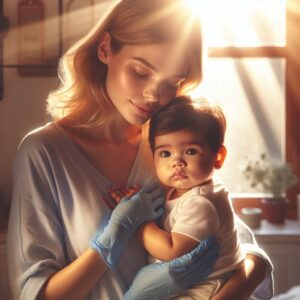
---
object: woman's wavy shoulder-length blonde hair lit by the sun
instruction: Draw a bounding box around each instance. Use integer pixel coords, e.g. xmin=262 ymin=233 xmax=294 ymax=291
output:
xmin=47 ymin=0 xmax=202 ymax=127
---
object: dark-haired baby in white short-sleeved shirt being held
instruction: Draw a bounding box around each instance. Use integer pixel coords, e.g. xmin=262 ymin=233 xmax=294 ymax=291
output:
xmin=110 ymin=97 xmax=243 ymax=300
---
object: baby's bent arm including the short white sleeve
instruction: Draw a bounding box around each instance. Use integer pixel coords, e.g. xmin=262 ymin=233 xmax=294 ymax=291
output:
xmin=138 ymin=195 xmax=219 ymax=261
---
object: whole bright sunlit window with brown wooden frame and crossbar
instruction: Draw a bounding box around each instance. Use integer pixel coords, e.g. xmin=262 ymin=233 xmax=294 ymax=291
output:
xmin=190 ymin=0 xmax=300 ymax=216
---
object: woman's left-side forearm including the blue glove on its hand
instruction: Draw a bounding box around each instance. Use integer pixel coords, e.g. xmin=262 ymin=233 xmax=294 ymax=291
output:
xmin=16 ymin=185 xmax=164 ymax=300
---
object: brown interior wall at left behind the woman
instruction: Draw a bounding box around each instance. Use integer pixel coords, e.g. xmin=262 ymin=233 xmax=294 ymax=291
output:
xmin=0 ymin=0 xmax=113 ymax=216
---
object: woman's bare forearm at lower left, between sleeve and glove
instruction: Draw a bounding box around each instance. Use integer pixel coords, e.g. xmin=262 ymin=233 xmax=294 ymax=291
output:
xmin=37 ymin=249 xmax=107 ymax=300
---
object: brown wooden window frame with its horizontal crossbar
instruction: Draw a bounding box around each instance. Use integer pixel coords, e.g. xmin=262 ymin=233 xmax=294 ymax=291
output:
xmin=208 ymin=0 xmax=300 ymax=219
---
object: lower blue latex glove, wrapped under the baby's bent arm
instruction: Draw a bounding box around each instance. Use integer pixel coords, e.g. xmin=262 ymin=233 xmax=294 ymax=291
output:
xmin=123 ymin=237 xmax=219 ymax=300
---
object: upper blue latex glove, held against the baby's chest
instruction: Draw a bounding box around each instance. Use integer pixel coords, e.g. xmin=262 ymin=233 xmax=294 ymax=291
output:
xmin=90 ymin=182 xmax=165 ymax=268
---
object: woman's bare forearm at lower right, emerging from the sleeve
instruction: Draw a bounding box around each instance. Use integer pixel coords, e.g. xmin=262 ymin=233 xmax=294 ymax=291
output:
xmin=212 ymin=254 xmax=267 ymax=300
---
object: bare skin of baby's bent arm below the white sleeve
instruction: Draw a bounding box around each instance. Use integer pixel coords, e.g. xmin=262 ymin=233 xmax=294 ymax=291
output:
xmin=138 ymin=221 xmax=199 ymax=261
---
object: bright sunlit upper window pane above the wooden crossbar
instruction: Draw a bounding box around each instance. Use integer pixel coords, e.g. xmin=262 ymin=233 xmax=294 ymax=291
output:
xmin=185 ymin=0 xmax=286 ymax=47
